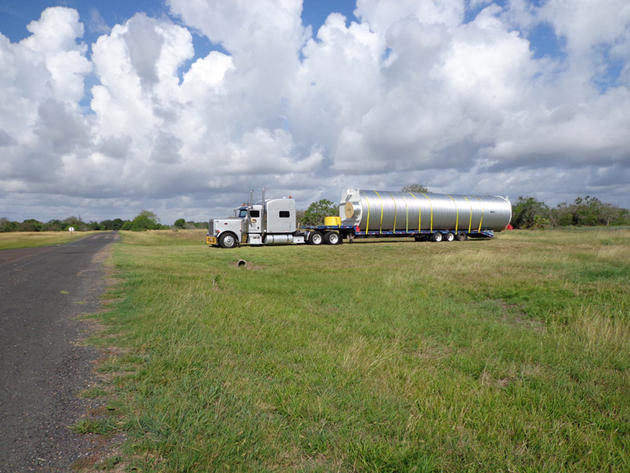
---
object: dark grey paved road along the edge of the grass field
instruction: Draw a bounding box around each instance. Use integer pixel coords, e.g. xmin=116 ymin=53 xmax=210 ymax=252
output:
xmin=0 ymin=233 xmax=116 ymax=473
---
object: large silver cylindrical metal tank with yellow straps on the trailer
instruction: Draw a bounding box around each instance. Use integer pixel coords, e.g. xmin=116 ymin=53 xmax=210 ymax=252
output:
xmin=339 ymin=189 xmax=512 ymax=232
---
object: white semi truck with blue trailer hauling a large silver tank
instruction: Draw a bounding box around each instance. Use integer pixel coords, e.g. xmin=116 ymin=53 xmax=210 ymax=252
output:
xmin=206 ymin=189 xmax=512 ymax=248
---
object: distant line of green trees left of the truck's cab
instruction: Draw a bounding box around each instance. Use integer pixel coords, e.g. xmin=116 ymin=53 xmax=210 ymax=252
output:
xmin=0 ymin=210 xmax=207 ymax=232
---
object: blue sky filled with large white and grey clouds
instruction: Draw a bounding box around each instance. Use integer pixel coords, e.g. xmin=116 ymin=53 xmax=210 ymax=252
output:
xmin=0 ymin=0 xmax=630 ymax=222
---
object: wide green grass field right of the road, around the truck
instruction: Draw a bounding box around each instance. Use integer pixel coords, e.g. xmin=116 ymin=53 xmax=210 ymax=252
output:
xmin=87 ymin=229 xmax=630 ymax=472
